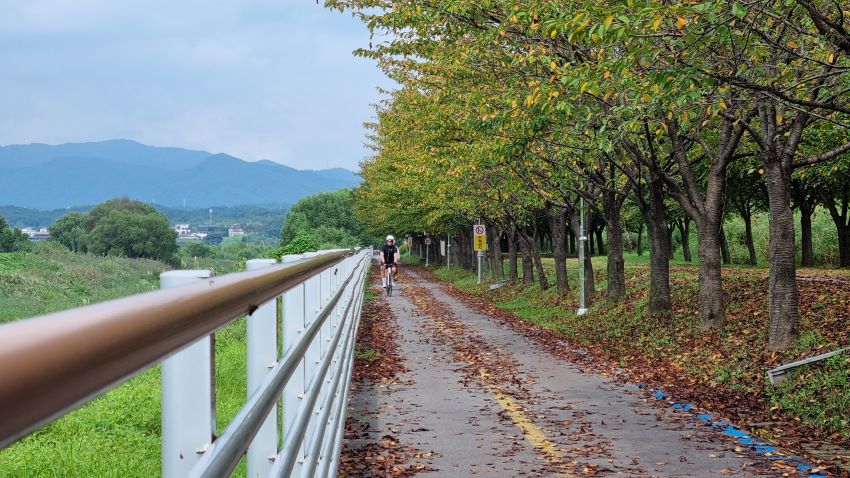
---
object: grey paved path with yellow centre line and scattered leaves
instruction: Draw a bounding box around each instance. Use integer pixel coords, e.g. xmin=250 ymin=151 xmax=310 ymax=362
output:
xmin=340 ymin=268 xmax=824 ymax=477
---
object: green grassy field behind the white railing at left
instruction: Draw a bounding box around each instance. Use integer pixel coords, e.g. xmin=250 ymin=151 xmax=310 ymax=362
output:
xmin=0 ymin=244 xmax=252 ymax=478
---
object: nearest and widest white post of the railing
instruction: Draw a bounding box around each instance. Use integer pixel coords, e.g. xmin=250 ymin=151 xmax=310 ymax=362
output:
xmin=159 ymin=270 xmax=215 ymax=478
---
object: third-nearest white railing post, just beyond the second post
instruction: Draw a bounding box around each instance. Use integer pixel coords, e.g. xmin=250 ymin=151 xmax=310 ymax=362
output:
xmin=281 ymin=250 xmax=306 ymax=456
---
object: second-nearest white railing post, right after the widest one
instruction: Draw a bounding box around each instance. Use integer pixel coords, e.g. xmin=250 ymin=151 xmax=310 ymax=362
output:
xmin=246 ymin=259 xmax=277 ymax=478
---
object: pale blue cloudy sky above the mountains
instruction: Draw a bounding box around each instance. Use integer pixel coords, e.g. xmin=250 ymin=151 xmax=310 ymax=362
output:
xmin=0 ymin=0 xmax=390 ymax=170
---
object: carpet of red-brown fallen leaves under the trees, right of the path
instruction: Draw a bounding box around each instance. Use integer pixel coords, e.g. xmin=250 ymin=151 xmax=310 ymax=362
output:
xmin=420 ymin=267 xmax=850 ymax=477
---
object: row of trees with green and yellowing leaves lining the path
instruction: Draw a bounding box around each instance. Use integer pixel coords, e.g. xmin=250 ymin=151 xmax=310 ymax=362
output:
xmin=325 ymin=0 xmax=850 ymax=350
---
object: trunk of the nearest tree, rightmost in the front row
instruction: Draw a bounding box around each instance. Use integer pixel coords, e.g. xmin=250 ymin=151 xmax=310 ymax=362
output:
xmin=763 ymin=159 xmax=800 ymax=350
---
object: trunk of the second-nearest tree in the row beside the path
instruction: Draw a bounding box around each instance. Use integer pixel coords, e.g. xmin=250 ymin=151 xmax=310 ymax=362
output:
xmin=697 ymin=218 xmax=726 ymax=329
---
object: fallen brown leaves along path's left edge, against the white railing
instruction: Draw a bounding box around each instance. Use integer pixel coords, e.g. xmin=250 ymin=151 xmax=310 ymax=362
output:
xmin=338 ymin=270 xmax=432 ymax=477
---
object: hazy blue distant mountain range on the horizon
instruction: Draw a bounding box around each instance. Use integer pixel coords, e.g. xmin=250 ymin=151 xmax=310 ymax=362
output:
xmin=0 ymin=140 xmax=360 ymax=209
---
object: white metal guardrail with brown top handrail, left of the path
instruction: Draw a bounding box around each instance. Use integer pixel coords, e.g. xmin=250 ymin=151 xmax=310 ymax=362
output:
xmin=0 ymin=250 xmax=371 ymax=477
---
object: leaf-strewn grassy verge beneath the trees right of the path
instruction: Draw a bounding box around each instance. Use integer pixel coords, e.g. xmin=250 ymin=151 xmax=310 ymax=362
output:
xmin=433 ymin=258 xmax=850 ymax=444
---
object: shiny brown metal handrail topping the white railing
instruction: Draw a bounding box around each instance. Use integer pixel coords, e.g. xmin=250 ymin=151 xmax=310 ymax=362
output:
xmin=0 ymin=251 xmax=351 ymax=447
